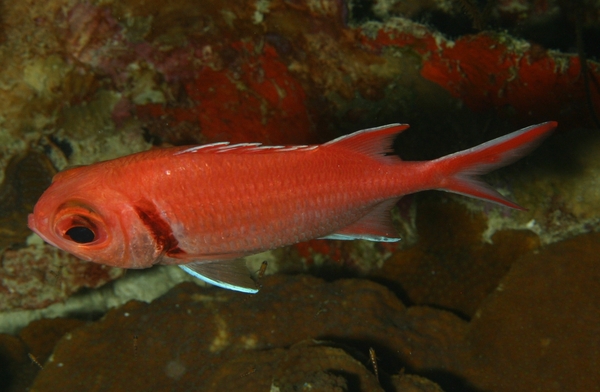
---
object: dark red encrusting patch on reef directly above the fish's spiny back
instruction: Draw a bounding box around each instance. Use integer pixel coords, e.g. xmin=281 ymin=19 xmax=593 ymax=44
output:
xmin=137 ymin=42 xmax=315 ymax=144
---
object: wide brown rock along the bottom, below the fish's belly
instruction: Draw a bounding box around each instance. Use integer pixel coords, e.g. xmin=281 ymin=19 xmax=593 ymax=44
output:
xmin=31 ymin=276 xmax=466 ymax=392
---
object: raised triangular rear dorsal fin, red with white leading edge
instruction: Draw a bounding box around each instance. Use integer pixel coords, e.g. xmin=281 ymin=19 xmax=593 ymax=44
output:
xmin=323 ymin=124 xmax=409 ymax=163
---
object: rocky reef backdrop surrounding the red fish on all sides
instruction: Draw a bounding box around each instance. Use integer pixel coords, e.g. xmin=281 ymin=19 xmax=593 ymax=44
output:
xmin=0 ymin=0 xmax=600 ymax=392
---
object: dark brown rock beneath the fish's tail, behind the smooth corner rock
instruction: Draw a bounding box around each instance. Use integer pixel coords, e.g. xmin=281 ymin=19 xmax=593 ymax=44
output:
xmin=369 ymin=195 xmax=541 ymax=318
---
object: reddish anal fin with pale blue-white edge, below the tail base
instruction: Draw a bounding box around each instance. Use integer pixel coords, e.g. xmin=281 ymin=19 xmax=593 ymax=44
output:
xmin=322 ymin=199 xmax=400 ymax=242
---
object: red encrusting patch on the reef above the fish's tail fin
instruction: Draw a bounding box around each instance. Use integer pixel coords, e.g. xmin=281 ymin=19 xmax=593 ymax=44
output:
xmin=362 ymin=25 xmax=600 ymax=124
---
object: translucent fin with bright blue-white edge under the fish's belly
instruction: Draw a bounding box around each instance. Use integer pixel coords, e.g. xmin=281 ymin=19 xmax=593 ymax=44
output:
xmin=179 ymin=259 xmax=258 ymax=294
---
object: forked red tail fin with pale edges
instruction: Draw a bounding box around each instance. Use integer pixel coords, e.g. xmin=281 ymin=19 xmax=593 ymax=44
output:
xmin=431 ymin=121 xmax=557 ymax=210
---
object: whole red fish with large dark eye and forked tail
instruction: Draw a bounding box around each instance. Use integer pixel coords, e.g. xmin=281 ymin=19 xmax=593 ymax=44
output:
xmin=28 ymin=121 xmax=557 ymax=293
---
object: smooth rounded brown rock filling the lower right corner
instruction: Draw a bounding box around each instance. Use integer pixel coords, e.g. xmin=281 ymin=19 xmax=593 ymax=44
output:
xmin=464 ymin=233 xmax=600 ymax=391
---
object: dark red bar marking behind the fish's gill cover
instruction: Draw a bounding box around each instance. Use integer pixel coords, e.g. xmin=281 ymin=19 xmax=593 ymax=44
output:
xmin=134 ymin=200 xmax=185 ymax=256
